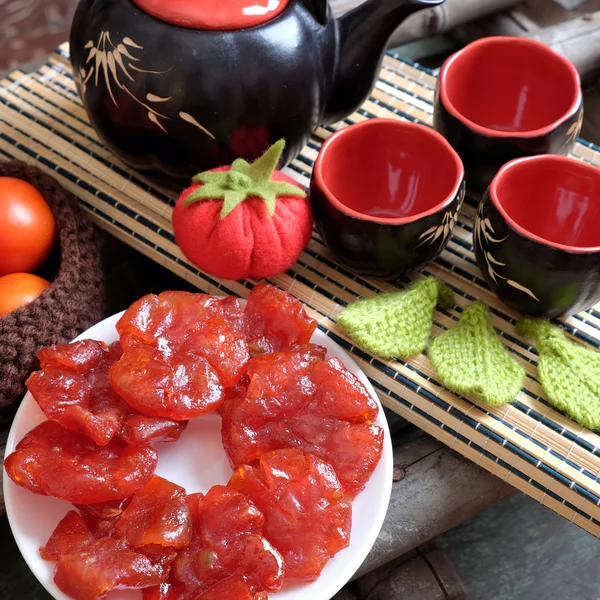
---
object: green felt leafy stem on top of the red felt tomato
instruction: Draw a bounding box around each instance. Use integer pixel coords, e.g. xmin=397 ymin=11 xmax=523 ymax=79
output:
xmin=184 ymin=140 xmax=306 ymax=219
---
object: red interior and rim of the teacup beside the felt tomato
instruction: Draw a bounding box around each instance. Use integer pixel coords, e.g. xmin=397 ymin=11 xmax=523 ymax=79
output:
xmin=315 ymin=119 xmax=464 ymax=224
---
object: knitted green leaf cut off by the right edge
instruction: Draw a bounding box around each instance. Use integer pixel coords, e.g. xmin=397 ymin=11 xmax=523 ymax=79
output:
xmin=517 ymin=319 xmax=600 ymax=429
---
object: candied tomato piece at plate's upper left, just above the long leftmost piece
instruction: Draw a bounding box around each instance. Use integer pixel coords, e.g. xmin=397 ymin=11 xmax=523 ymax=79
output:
xmin=27 ymin=340 xmax=185 ymax=446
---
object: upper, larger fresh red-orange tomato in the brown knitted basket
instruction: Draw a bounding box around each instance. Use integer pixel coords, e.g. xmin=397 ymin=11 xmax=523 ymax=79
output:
xmin=0 ymin=177 xmax=56 ymax=276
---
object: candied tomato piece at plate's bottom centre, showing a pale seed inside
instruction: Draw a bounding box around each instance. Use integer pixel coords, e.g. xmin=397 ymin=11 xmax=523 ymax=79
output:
xmin=172 ymin=486 xmax=284 ymax=594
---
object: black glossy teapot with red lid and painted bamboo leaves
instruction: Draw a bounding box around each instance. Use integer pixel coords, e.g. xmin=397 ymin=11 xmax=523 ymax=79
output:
xmin=71 ymin=0 xmax=444 ymax=179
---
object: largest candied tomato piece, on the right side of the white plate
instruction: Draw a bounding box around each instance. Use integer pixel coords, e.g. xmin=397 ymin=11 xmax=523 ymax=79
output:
xmin=221 ymin=347 xmax=383 ymax=498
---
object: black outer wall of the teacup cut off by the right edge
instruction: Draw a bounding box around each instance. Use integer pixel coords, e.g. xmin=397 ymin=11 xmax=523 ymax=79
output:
xmin=473 ymin=190 xmax=600 ymax=318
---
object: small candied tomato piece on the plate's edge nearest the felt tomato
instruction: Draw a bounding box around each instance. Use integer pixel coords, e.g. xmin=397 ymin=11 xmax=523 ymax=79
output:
xmin=245 ymin=283 xmax=317 ymax=355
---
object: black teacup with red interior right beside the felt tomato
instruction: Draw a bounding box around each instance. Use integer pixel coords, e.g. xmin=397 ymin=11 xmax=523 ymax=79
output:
xmin=310 ymin=119 xmax=464 ymax=277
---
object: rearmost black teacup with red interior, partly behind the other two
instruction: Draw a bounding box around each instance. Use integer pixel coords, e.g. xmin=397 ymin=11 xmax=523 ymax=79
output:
xmin=434 ymin=37 xmax=583 ymax=193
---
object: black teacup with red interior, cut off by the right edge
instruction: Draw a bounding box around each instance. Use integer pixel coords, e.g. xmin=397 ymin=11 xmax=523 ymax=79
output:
xmin=473 ymin=155 xmax=600 ymax=318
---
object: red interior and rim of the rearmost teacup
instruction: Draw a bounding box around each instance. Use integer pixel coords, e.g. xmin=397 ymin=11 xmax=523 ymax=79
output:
xmin=440 ymin=37 xmax=581 ymax=135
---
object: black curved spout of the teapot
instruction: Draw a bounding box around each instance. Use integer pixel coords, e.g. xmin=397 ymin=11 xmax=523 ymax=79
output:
xmin=323 ymin=0 xmax=445 ymax=125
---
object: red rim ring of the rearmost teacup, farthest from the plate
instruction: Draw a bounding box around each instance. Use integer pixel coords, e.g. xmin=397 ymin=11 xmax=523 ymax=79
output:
xmin=439 ymin=36 xmax=582 ymax=138
